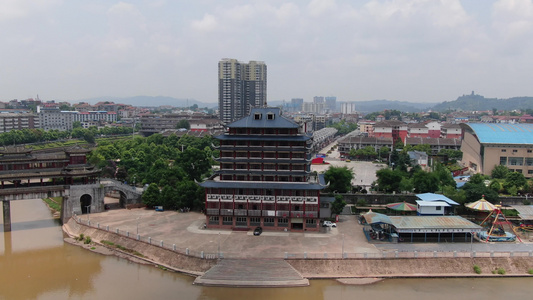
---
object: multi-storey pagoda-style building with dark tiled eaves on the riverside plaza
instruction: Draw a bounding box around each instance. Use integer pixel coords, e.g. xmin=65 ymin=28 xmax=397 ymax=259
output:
xmin=200 ymin=107 xmax=325 ymax=232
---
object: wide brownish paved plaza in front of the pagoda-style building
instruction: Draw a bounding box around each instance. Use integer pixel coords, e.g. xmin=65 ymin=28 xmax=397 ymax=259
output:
xmin=79 ymin=208 xmax=379 ymax=258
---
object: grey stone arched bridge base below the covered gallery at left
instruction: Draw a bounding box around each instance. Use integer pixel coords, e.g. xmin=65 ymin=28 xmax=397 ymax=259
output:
xmin=0 ymin=179 xmax=143 ymax=232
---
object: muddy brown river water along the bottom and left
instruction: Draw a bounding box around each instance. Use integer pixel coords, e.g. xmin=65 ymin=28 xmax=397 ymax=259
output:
xmin=0 ymin=200 xmax=533 ymax=300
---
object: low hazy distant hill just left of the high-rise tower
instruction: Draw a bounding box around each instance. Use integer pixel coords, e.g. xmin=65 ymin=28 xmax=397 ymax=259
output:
xmin=79 ymin=96 xmax=218 ymax=108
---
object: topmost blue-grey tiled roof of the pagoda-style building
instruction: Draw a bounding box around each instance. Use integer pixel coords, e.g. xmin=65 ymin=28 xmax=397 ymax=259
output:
xmin=228 ymin=107 xmax=300 ymax=128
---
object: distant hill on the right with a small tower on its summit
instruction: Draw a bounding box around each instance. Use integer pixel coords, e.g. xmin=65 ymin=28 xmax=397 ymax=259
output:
xmin=431 ymin=93 xmax=533 ymax=112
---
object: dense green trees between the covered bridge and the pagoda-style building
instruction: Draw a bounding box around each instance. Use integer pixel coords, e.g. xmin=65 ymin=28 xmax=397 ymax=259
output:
xmin=88 ymin=134 xmax=218 ymax=210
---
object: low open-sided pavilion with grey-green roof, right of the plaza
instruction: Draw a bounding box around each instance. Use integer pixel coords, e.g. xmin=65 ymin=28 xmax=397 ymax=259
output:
xmin=363 ymin=213 xmax=483 ymax=243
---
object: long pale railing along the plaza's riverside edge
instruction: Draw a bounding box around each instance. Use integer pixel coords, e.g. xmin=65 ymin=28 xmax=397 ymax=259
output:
xmin=74 ymin=216 xmax=533 ymax=260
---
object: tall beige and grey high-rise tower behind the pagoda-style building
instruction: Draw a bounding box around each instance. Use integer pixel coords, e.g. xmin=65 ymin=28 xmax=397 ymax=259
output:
xmin=218 ymin=58 xmax=267 ymax=124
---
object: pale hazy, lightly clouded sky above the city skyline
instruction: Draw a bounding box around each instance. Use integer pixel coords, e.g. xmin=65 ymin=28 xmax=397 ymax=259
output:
xmin=0 ymin=0 xmax=533 ymax=103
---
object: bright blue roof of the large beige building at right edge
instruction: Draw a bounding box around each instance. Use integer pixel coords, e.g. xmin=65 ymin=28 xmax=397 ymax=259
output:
xmin=466 ymin=123 xmax=533 ymax=144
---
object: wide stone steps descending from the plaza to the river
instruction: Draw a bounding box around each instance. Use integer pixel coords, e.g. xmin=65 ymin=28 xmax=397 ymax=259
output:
xmin=194 ymin=259 xmax=309 ymax=287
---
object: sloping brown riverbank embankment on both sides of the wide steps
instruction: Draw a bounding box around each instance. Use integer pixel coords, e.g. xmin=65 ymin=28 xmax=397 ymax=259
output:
xmin=63 ymin=219 xmax=533 ymax=284
